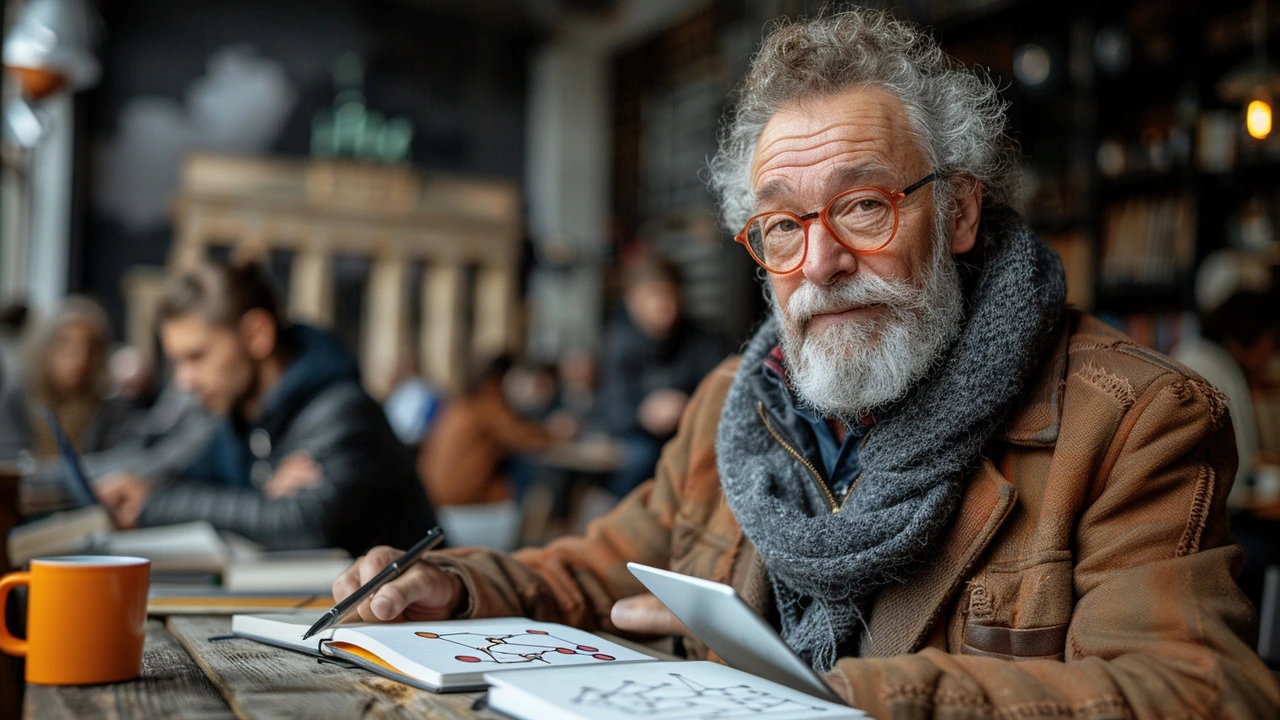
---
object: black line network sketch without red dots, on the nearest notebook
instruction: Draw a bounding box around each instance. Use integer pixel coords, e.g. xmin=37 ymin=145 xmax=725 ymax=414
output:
xmin=573 ymin=673 xmax=827 ymax=720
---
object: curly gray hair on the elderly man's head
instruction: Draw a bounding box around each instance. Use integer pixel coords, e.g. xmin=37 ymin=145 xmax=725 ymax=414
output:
xmin=708 ymin=8 xmax=1018 ymax=233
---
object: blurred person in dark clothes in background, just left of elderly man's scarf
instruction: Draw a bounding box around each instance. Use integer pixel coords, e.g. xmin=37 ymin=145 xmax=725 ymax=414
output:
xmin=599 ymin=258 xmax=723 ymax=497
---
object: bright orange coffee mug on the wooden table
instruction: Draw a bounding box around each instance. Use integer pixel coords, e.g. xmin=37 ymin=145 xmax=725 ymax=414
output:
xmin=0 ymin=555 xmax=151 ymax=685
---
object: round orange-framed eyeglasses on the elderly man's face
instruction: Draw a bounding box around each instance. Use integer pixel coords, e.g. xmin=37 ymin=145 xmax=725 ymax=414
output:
xmin=733 ymin=173 xmax=938 ymax=275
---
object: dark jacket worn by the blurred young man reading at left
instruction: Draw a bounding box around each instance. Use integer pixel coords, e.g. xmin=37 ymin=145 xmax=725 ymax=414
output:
xmin=141 ymin=325 xmax=435 ymax=555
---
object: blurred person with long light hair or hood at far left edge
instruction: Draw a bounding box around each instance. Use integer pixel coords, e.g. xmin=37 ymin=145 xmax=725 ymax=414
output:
xmin=0 ymin=296 xmax=129 ymax=461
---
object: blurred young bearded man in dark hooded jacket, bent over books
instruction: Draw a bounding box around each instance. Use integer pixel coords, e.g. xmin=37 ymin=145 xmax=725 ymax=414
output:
xmin=99 ymin=264 xmax=435 ymax=555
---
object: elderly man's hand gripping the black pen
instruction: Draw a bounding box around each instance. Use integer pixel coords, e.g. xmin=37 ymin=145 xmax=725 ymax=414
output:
xmin=333 ymin=544 xmax=467 ymax=623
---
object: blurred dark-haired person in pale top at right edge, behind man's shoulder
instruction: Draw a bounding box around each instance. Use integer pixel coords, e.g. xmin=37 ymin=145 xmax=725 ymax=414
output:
xmin=1172 ymin=292 xmax=1280 ymax=507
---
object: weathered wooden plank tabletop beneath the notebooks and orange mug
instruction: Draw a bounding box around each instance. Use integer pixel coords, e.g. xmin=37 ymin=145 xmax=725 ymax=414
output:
xmin=23 ymin=615 xmax=672 ymax=720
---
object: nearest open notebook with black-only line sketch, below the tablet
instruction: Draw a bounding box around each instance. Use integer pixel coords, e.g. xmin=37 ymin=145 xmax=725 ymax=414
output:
xmin=484 ymin=662 xmax=868 ymax=720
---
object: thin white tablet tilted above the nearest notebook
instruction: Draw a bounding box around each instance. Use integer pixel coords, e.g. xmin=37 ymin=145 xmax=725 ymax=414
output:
xmin=627 ymin=562 xmax=847 ymax=705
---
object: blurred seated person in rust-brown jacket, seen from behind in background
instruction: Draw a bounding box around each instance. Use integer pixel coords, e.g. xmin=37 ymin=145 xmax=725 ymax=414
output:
xmin=419 ymin=355 xmax=576 ymax=507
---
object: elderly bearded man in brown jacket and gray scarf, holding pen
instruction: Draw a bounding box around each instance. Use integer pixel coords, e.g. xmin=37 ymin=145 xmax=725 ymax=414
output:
xmin=334 ymin=10 xmax=1280 ymax=717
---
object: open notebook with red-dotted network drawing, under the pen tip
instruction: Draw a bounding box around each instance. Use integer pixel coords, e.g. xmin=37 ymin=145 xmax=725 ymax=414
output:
xmin=232 ymin=612 xmax=654 ymax=692
